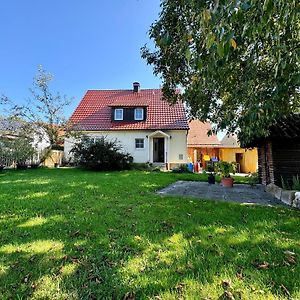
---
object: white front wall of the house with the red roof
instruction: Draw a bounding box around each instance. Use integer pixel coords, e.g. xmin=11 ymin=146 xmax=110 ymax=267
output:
xmin=65 ymin=130 xmax=187 ymax=164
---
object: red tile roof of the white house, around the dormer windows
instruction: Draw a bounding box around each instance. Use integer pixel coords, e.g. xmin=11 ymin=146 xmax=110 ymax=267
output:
xmin=70 ymin=89 xmax=189 ymax=131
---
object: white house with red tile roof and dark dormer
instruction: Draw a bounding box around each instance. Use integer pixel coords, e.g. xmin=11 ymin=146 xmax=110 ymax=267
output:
xmin=65 ymin=82 xmax=189 ymax=168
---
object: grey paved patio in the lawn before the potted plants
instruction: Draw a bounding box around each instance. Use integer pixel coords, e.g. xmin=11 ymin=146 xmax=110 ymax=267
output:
xmin=157 ymin=181 xmax=283 ymax=205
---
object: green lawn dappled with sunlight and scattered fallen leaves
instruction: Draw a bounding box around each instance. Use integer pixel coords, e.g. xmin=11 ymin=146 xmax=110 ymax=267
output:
xmin=0 ymin=169 xmax=300 ymax=299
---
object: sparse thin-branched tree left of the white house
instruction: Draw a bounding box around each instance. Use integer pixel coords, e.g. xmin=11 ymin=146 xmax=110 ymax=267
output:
xmin=0 ymin=66 xmax=72 ymax=149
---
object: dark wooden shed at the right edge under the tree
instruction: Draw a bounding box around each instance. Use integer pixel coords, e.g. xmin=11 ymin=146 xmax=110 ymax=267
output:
xmin=248 ymin=114 xmax=300 ymax=185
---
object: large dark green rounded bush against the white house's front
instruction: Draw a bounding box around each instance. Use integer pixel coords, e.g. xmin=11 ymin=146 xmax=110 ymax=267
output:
xmin=70 ymin=136 xmax=133 ymax=170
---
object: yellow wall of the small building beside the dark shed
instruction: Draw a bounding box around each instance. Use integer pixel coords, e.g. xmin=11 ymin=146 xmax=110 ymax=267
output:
xmin=219 ymin=148 xmax=258 ymax=173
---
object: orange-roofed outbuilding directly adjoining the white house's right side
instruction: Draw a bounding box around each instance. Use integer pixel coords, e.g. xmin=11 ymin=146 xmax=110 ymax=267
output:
xmin=188 ymin=120 xmax=221 ymax=169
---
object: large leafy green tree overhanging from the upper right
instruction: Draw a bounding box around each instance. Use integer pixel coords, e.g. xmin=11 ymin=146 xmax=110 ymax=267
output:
xmin=142 ymin=0 xmax=300 ymax=144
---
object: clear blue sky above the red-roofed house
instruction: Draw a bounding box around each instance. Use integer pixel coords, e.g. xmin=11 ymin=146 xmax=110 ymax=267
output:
xmin=0 ymin=0 xmax=160 ymax=116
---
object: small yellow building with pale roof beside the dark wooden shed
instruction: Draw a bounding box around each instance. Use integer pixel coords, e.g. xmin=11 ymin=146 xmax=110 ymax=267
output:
xmin=219 ymin=135 xmax=258 ymax=173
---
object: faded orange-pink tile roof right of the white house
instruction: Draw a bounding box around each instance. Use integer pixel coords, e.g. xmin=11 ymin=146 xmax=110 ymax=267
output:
xmin=188 ymin=120 xmax=221 ymax=147
